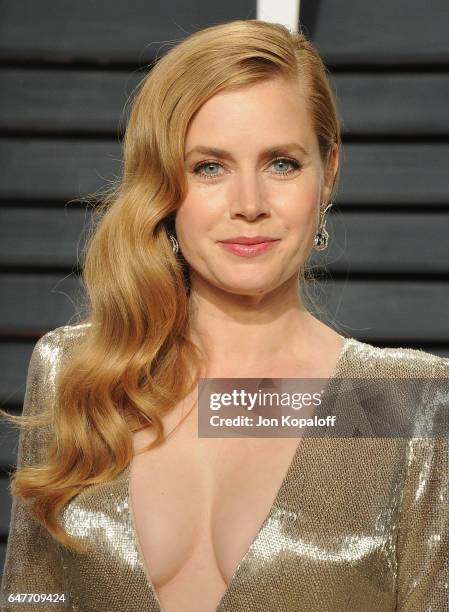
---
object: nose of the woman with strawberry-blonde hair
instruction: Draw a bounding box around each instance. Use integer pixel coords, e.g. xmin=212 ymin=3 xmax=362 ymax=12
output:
xmin=230 ymin=170 xmax=270 ymax=221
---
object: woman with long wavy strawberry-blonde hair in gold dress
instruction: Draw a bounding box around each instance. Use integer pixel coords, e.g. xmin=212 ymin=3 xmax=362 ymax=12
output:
xmin=2 ymin=20 xmax=449 ymax=612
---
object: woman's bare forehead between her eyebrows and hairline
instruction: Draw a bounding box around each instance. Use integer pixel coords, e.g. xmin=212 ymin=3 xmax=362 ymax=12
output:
xmin=185 ymin=78 xmax=313 ymax=150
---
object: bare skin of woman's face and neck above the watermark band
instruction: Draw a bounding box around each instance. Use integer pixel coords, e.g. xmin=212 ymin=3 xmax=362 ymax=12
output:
xmin=175 ymin=78 xmax=342 ymax=376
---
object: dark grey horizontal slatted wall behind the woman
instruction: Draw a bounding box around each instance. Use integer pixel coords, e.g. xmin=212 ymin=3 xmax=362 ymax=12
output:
xmin=0 ymin=0 xmax=449 ymax=570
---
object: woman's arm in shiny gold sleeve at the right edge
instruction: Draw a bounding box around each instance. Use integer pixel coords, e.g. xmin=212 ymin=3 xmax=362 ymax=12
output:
xmin=396 ymin=358 xmax=449 ymax=612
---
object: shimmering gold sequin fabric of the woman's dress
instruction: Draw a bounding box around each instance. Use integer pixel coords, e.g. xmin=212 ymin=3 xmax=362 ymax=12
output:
xmin=2 ymin=324 xmax=449 ymax=612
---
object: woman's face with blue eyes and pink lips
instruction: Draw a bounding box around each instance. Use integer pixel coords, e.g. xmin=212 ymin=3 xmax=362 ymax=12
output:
xmin=175 ymin=79 xmax=336 ymax=296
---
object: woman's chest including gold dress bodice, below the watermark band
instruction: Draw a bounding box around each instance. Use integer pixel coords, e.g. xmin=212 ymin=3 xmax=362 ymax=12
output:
xmin=63 ymin=430 xmax=406 ymax=612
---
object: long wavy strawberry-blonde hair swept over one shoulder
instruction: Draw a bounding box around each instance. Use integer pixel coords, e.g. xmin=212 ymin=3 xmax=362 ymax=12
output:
xmin=2 ymin=20 xmax=341 ymax=550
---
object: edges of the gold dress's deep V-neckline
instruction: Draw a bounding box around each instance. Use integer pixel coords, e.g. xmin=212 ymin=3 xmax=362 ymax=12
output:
xmin=124 ymin=337 xmax=356 ymax=612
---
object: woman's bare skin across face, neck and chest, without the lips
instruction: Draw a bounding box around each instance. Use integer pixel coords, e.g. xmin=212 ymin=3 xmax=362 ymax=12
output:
xmin=130 ymin=80 xmax=341 ymax=610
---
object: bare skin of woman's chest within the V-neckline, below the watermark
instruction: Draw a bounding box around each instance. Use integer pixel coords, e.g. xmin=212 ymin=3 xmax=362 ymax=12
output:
xmin=129 ymin=427 xmax=299 ymax=612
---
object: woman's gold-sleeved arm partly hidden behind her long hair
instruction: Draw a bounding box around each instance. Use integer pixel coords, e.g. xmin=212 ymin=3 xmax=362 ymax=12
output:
xmin=0 ymin=328 xmax=66 ymax=612
